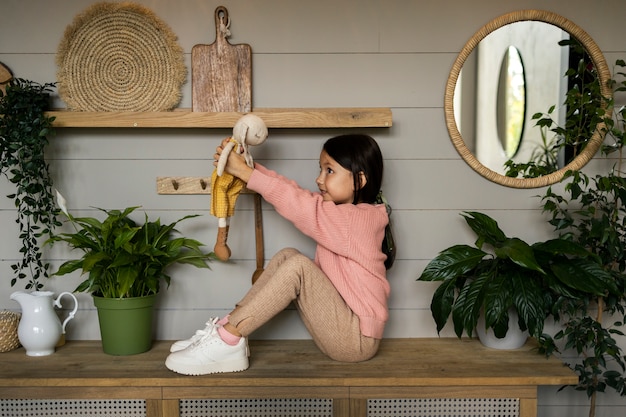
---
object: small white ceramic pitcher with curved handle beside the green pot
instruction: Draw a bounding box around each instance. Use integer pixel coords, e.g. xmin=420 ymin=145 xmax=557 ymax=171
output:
xmin=11 ymin=291 xmax=78 ymax=356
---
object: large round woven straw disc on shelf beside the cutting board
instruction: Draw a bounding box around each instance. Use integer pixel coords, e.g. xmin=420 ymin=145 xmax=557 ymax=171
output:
xmin=56 ymin=2 xmax=187 ymax=111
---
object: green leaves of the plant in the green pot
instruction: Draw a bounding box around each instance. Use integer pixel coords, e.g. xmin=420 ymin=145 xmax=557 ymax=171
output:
xmin=49 ymin=196 xmax=215 ymax=298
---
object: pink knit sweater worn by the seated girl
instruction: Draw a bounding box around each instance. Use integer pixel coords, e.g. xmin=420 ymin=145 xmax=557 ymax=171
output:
xmin=248 ymin=164 xmax=389 ymax=339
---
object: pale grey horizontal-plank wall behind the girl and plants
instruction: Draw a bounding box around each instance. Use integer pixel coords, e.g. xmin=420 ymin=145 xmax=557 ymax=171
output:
xmin=0 ymin=0 xmax=626 ymax=417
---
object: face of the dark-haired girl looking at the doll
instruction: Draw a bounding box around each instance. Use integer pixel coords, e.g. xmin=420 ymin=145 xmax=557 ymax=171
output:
xmin=315 ymin=150 xmax=354 ymax=204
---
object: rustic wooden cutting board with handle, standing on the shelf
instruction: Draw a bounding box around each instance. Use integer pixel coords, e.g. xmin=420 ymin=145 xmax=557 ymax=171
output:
xmin=191 ymin=6 xmax=252 ymax=112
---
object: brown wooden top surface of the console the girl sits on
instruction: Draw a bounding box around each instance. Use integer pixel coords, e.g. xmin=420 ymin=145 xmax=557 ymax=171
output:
xmin=0 ymin=338 xmax=578 ymax=391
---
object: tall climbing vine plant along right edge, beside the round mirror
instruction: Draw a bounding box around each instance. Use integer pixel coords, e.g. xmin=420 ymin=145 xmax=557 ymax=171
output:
xmin=541 ymin=60 xmax=626 ymax=417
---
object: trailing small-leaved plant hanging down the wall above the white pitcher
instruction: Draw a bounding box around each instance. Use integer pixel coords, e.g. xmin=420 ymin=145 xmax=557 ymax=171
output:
xmin=0 ymin=78 xmax=60 ymax=290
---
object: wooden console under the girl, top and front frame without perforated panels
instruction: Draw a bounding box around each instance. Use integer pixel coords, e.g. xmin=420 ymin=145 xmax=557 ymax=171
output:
xmin=0 ymin=338 xmax=578 ymax=417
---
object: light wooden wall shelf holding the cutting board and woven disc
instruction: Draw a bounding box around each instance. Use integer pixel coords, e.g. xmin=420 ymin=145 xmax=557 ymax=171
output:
xmin=47 ymin=107 xmax=392 ymax=129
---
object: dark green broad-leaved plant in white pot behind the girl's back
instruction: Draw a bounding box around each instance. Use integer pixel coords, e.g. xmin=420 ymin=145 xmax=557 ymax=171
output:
xmin=418 ymin=212 xmax=611 ymax=349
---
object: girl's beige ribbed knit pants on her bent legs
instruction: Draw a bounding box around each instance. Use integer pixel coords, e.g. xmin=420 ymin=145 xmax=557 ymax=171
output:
xmin=229 ymin=248 xmax=380 ymax=362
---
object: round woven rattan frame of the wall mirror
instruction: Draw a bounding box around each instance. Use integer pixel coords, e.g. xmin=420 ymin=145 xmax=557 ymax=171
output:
xmin=444 ymin=10 xmax=613 ymax=188
